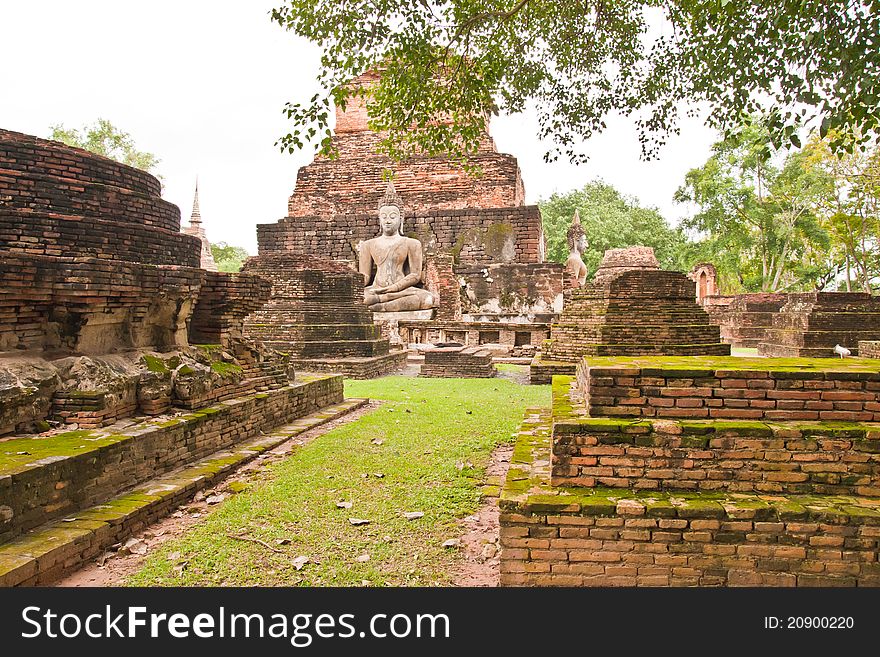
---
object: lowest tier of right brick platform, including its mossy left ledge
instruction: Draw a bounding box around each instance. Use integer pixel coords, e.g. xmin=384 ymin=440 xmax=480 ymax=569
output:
xmin=499 ymin=402 xmax=880 ymax=586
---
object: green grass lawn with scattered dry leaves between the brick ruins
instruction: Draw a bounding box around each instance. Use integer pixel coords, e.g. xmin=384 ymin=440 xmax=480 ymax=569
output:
xmin=127 ymin=377 xmax=550 ymax=586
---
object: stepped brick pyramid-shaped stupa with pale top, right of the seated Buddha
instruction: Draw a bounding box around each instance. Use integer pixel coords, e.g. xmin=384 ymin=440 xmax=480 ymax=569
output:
xmin=531 ymin=247 xmax=730 ymax=383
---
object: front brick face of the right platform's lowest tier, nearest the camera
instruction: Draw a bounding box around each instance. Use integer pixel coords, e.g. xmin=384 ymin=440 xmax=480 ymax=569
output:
xmin=501 ymin=500 xmax=880 ymax=586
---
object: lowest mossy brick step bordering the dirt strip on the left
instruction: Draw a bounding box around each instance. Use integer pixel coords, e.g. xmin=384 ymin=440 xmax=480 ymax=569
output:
xmin=0 ymin=399 xmax=368 ymax=586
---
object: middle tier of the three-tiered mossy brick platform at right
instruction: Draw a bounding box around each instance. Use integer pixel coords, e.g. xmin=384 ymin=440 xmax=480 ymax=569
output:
xmin=551 ymin=418 xmax=880 ymax=497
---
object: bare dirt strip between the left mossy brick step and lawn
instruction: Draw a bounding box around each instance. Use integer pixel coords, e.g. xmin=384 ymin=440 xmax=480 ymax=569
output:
xmin=55 ymin=401 xmax=381 ymax=587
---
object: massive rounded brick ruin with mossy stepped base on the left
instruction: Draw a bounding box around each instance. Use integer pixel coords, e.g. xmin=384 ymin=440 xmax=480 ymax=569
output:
xmin=0 ymin=130 xmax=349 ymax=585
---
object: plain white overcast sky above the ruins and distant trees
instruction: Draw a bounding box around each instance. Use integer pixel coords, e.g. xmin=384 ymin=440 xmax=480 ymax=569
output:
xmin=0 ymin=0 xmax=716 ymax=253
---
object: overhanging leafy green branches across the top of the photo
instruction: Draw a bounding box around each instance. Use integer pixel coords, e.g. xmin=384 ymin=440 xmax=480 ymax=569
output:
xmin=271 ymin=0 xmax=880 ymax=161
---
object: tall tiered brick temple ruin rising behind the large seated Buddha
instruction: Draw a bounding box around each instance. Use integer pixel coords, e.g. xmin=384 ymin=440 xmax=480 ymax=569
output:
xmin=251 ymin=73 xmax=564 ymax=349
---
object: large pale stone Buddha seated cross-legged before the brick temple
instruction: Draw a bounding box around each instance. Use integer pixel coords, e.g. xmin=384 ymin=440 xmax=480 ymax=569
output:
xmin=358 ymin=181 xmax=436 ymax=312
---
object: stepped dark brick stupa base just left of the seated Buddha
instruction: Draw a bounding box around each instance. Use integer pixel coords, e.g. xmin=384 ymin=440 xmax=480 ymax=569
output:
xmin=242 ymin=254 xmax=406 ymax=379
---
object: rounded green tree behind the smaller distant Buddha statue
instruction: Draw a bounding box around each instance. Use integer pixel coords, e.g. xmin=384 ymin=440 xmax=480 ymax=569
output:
xmin=538 ymin=180 xmax=685 ymax=275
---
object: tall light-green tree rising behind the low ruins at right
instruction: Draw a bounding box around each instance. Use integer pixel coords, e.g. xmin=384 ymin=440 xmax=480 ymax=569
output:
xmin=674 ymin=120 xmax=833 ymax=292
